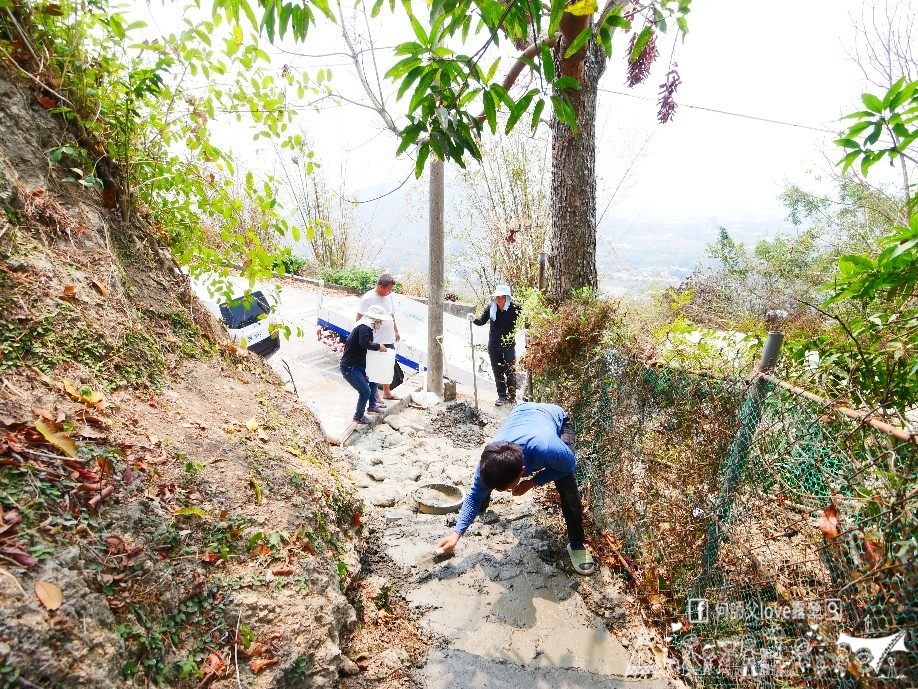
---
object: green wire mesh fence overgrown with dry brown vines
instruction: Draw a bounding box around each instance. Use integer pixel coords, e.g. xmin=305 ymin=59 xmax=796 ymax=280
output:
xmin=548 ymin=344 xmax=918 ymax=687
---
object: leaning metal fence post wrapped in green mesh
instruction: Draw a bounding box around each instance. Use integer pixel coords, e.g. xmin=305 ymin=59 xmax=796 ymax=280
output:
xmin=694 ymin=331 xmax=784 ymax=598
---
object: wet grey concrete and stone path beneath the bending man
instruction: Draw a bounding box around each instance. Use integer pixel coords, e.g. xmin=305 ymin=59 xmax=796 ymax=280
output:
xmin=339 ymin=403 xmax=674 ymax=689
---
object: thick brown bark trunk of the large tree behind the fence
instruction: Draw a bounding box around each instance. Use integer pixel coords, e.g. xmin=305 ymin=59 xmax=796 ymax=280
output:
xmin=549 ymin=33 xmax=606 ymax=300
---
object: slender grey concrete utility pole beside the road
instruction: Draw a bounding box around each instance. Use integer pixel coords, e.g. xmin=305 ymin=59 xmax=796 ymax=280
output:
xmin=427 ymin=152 xmax=444 ymax=397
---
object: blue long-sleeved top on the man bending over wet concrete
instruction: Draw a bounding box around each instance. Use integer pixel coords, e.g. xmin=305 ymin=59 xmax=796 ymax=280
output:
xmin=455 ymin=402 xmax=577 ymax=535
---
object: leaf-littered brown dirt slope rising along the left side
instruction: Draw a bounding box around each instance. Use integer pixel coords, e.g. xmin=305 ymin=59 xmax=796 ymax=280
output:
xmin=0 ymin=69 xmax=378 ymax=687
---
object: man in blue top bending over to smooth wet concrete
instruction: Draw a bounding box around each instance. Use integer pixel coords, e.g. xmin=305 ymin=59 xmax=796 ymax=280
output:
xmin=437 ymin=402 xmax=595 ymax=574
